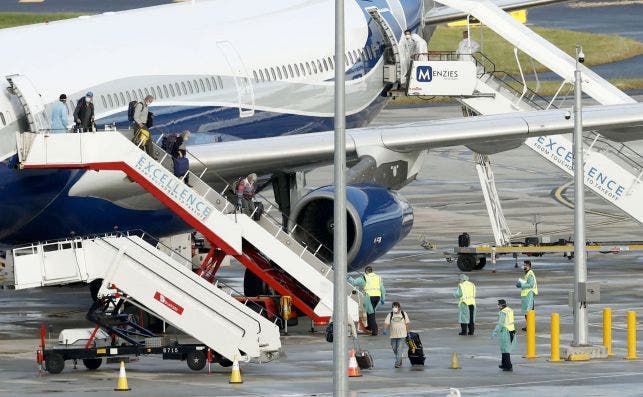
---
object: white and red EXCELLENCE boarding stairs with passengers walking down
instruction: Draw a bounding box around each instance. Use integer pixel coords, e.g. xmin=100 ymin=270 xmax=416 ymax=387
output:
xmin=16 ymin=131 xmax=359 ymax=322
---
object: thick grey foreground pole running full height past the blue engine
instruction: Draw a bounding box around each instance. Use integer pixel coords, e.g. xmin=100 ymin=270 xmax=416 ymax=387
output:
xmin=333 ymin=0 xmax=348 ymax=397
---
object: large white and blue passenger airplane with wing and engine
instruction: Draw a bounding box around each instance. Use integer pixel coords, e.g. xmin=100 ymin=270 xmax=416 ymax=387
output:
xmin=0 ymin=0 xmax=643 ymax=294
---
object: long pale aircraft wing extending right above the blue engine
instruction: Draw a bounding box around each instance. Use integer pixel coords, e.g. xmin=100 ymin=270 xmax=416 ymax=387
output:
xmin=190 ymin=103 xmax=643 ymax=179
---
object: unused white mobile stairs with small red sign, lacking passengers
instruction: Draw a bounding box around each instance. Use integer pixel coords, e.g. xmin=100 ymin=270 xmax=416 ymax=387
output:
xmin=7 ymin=235 xmax=281 ymax=361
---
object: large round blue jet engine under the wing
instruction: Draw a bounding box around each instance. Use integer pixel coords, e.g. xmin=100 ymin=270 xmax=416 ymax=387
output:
xmin=290 ymin=184 xmax=413 ymax=270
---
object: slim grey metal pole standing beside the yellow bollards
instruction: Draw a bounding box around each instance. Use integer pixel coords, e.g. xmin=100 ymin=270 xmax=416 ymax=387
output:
xmin=572 ymin=45 xmax=587 ymax=346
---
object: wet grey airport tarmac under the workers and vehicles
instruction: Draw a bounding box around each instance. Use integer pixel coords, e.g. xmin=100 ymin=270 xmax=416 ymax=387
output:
xmin=0 ymin=105 xmax=643 ymax=396
